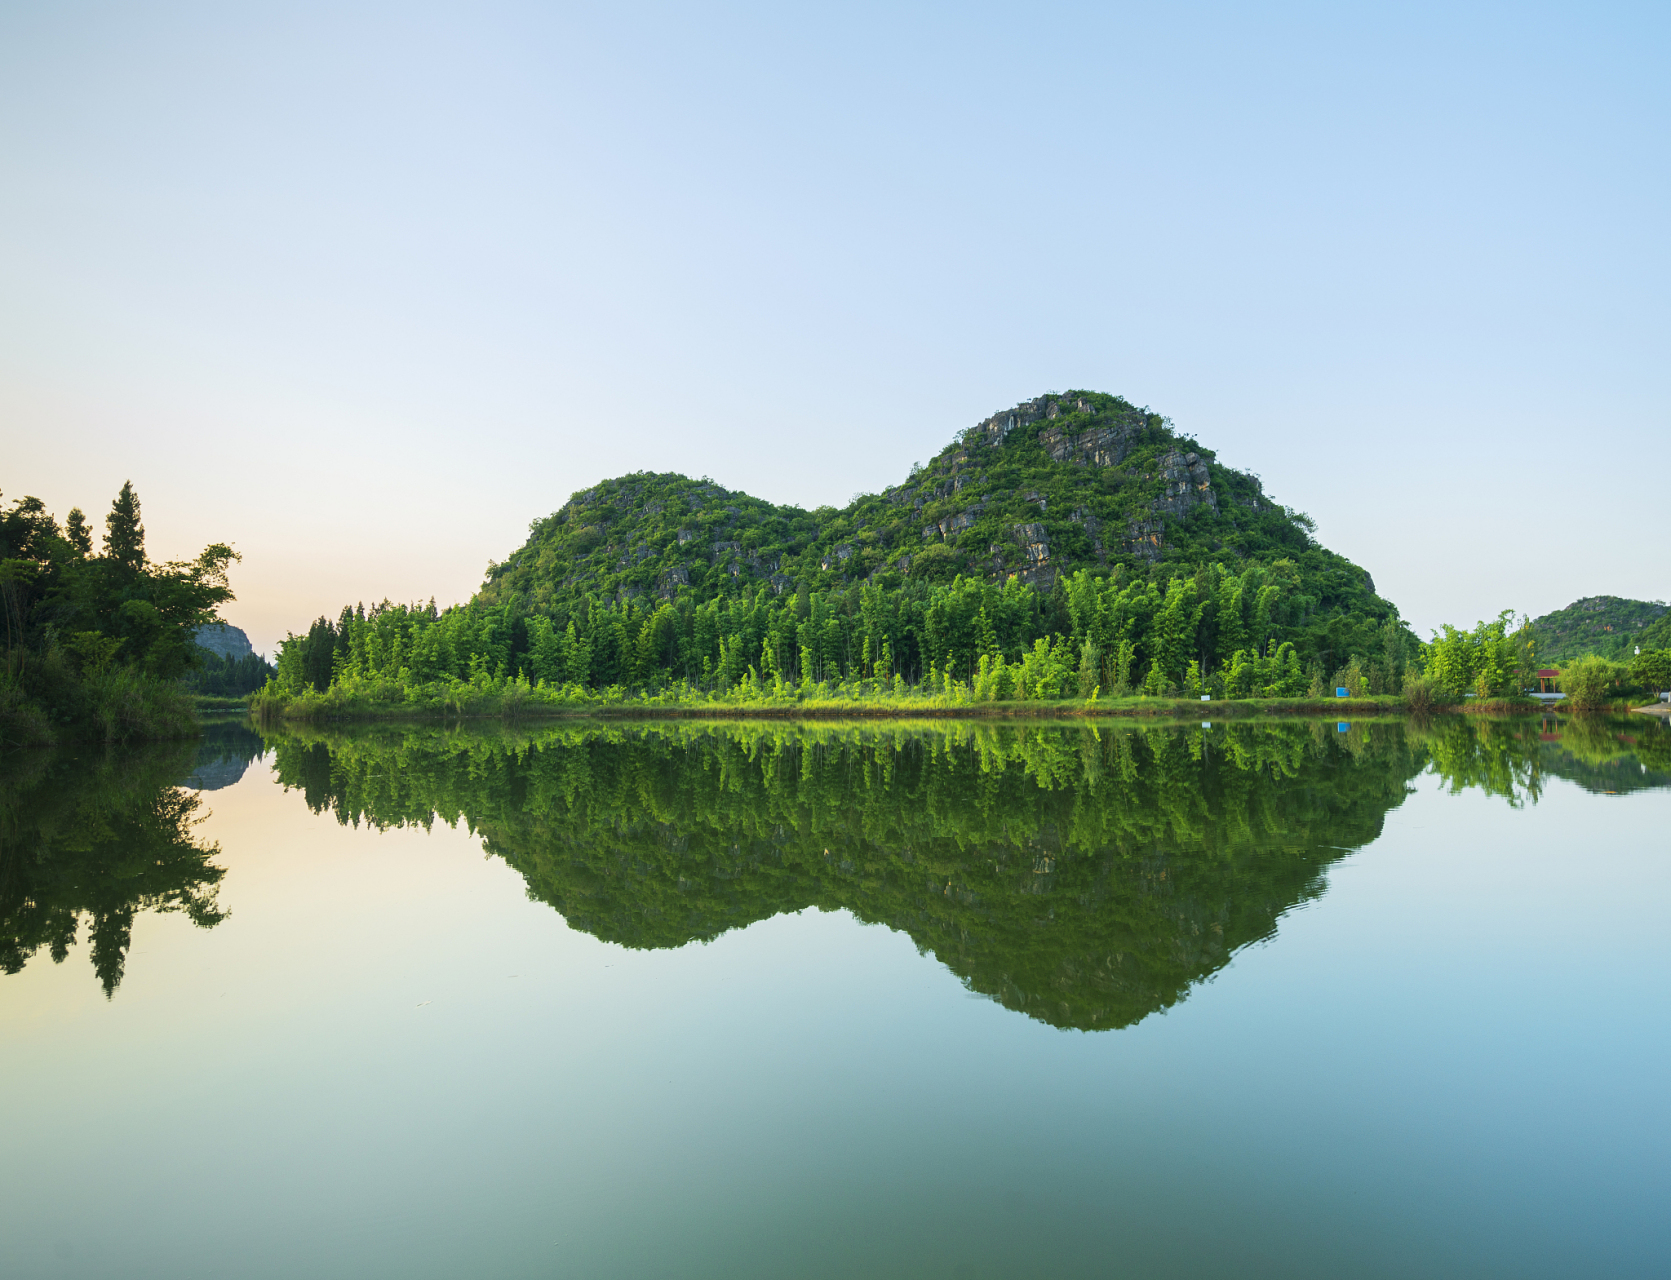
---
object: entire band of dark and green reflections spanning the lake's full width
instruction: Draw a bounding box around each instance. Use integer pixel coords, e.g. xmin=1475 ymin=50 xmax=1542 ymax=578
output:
xmin=0 ymin=717 xmax=1671 ymax=1029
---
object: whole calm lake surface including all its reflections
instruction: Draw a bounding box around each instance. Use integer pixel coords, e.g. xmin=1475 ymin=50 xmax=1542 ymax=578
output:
xmin=0 ymin=717 xmax=1671 ymax=1277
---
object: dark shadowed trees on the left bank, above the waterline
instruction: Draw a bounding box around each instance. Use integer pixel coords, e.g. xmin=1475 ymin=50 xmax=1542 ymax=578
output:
xmin=0 ymin=485 xmax=237 ymax=745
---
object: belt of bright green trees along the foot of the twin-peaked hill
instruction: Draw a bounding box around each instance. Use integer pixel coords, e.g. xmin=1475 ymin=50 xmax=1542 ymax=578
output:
xmin=272 ymin=561 xmax=1420 ymax=700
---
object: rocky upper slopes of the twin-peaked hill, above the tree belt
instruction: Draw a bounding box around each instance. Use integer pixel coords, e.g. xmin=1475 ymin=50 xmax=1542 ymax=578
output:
xmin=476 ymin=391 xmax=1395 ymax=617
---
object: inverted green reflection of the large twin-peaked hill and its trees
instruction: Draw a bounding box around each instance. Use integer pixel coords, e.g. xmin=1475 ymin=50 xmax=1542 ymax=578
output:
xmin=267 ymin=724 xmax=1422 ymax=1029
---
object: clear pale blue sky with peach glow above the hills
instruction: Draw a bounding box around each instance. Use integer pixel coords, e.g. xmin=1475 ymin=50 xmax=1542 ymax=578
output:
xmin=0 ymin=0 xmax=1671 ymax=653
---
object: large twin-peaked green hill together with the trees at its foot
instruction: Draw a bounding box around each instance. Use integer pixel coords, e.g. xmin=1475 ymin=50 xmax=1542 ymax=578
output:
xmin=269 ymin=393 xmax=1420 ymax=702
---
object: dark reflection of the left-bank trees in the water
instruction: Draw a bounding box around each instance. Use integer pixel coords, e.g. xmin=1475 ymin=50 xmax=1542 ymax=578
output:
xmin=0 ymin=745 xmax=226 ymax=996
